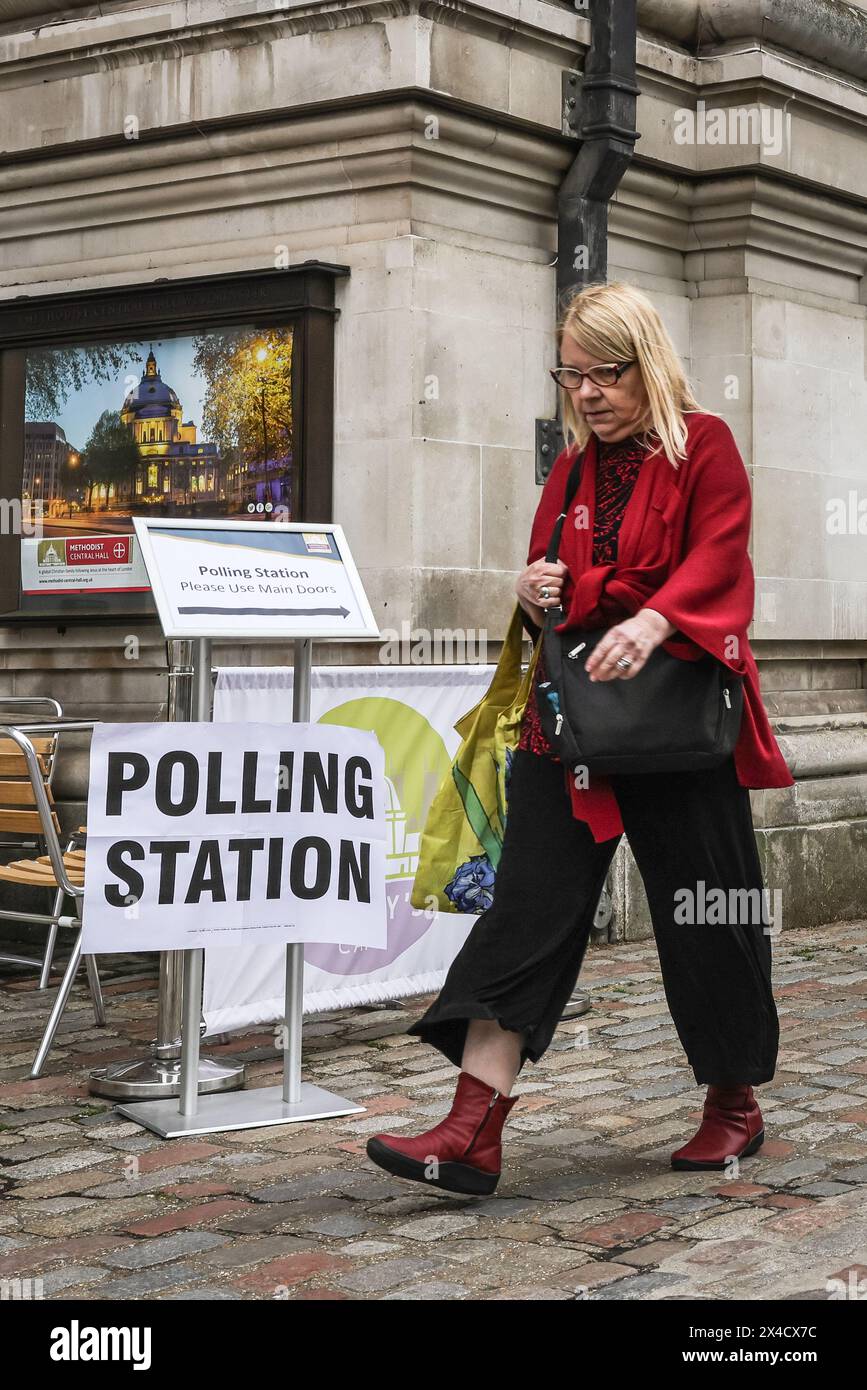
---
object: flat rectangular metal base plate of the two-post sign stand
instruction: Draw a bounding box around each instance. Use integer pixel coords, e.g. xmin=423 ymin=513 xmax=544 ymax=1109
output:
xmin=115 ymin=1081 xmax=364 ymax=1138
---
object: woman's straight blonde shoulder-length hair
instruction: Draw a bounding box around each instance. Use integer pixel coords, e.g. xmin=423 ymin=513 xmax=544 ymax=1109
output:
xmin=557 ymin=281 xmax=702 ymax=468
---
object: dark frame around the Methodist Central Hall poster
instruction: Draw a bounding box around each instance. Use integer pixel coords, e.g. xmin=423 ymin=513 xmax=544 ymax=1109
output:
xmin=0 ymin=260 xmax=349 ymax=624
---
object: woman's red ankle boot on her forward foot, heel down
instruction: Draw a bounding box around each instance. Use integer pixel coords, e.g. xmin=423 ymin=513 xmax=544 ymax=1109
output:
xmin=367 ymin=1072 xmax=518 ymax=1197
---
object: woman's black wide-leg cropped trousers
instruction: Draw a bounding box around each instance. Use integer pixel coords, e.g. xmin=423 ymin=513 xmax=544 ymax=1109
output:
xmin=407 ymin=748 xmax=779 ymax=1086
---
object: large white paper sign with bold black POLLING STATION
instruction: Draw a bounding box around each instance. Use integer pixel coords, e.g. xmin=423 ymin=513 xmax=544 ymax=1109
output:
xmin=82 ymin=723 xmax=388 ymax=954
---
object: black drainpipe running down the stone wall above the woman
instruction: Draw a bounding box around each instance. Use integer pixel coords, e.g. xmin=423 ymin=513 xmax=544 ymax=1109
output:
xmin=536 ymin=0 xmax=639 ymax=482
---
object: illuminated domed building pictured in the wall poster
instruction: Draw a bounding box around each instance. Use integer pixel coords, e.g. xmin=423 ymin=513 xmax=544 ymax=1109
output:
xmin=118 ymin=348 xmax=229 ymax=506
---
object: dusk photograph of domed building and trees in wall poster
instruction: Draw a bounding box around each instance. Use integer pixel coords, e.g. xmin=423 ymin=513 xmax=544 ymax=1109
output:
xmin=25 ymin=327 xmax=297 ymax=535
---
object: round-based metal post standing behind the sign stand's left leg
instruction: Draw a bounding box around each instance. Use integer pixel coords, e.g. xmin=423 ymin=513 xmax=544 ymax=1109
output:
xmin=89 ymin=639 xmax=245 ymax=1101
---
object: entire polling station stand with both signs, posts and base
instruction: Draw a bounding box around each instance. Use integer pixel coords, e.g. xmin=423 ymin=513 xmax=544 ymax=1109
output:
xmin=102 ymin=517 xmax=388 ymax=1138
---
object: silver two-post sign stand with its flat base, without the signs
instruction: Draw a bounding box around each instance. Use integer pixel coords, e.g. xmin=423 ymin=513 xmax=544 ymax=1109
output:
xmin=117 ymin=637 xmax=364 ymax=1138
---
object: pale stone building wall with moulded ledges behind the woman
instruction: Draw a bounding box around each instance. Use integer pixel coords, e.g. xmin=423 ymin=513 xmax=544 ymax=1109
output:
xmin=0 ymin=0 xmax=867 ymax=935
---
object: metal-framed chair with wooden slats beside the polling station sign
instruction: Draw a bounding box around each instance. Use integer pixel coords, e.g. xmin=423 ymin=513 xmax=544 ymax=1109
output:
xmin=0 ymin=720 xmax=106 ymax=1077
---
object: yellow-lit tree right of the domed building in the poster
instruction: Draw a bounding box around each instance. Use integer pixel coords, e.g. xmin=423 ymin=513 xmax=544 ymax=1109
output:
xmin=193 ymin=328 xmax=292 ymax=502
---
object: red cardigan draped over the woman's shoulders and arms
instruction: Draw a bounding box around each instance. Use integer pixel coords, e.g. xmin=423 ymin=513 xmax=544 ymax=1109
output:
xmin=527 ymin=411 xmax=793 ymax=840
